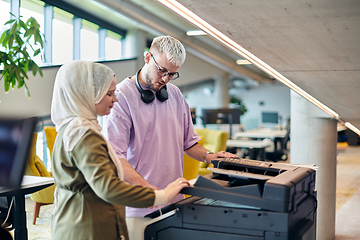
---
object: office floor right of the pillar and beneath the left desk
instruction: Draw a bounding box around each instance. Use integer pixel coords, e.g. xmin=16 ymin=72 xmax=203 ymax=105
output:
xmin=7 ymin=146 xmax=360 ymax=240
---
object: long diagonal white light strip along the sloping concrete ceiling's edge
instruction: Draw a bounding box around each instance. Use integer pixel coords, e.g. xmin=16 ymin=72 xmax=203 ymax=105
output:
xmin=158 ymin=0 xmax=339 ymax=119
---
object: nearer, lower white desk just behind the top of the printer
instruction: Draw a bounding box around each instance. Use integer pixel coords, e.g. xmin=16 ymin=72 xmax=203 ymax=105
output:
xmin=226 ymin=139 xmax=273 ymax=160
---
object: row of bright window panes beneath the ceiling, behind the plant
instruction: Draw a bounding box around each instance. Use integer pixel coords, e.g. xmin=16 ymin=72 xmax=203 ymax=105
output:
xmin=0 ymin=0 xmax=124 ymax=66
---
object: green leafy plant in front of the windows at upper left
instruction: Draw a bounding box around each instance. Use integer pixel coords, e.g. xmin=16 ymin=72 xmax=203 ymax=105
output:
xmin=0 ymin=13 xmax=44 ymax=97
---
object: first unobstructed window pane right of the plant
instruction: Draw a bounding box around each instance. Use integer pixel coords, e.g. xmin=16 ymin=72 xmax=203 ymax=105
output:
xmin=52 ymin=7 xmax=74 ymax=65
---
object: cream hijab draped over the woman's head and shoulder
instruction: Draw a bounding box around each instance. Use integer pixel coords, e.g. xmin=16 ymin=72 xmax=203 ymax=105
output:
xmin=51 ymin=61 xmax=124 ymax=180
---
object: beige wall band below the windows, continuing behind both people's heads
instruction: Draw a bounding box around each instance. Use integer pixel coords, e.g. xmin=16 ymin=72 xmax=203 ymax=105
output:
xmin=0 ymin=50 xmax=223 ymax=117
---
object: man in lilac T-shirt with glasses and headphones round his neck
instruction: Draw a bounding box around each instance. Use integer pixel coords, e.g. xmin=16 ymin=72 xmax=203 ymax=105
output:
xmin=104 ymin=36 xmax=235 ymax=240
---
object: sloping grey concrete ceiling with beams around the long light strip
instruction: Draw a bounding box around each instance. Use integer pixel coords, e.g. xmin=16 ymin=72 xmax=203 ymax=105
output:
xmin=66 ymin=0 xmax=360 ymax=129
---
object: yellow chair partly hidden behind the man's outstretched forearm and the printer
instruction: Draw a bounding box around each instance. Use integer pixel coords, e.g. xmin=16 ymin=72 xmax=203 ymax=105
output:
xmin=195 ymin=128 xmax=229 ymax=175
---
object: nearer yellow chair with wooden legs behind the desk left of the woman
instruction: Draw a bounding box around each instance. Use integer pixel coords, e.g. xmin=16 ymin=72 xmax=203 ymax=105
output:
xmin=25 ymin=133 xmax=55 ymax=225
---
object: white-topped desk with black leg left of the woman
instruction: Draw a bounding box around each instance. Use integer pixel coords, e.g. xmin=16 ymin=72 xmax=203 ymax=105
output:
xmin=0 ymin=176 xmax=54 ymax=240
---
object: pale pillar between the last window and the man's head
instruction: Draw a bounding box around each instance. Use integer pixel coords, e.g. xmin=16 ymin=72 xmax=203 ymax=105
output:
xmin=121 ymin=30 xmax=147 ymax=71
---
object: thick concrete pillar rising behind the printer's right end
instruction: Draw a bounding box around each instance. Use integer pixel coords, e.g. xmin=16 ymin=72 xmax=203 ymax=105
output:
xmin=290 ymin=91 xmax=337 ymax=240
